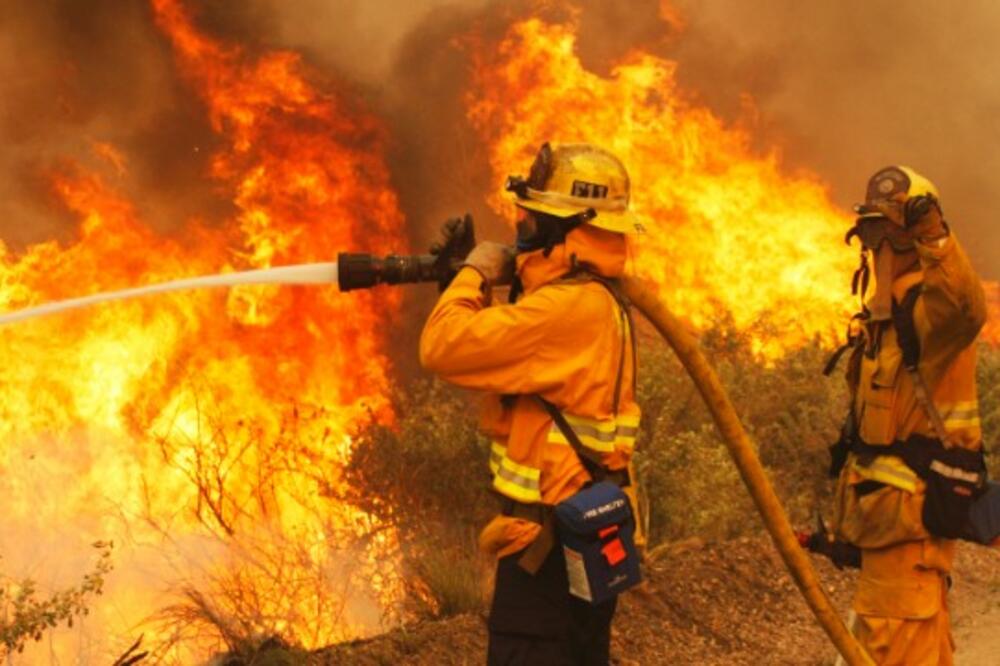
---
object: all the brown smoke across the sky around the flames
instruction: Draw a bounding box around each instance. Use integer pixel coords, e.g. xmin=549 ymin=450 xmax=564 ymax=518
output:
xmin=0 ymin=0 xmax=1000 ymax=278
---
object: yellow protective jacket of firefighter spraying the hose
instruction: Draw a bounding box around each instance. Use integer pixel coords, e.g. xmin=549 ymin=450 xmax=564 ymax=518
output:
xmin=420 ymin=227 xmax=639 ymax=556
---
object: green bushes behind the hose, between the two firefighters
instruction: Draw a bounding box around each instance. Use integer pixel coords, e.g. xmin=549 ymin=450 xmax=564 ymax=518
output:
xmin=636 ymin=326 xmax=846 ymax=545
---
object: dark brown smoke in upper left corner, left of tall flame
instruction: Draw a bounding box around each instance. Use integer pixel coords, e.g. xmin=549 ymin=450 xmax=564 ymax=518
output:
xmin=0 ymin=0 xmax=236 ymax=248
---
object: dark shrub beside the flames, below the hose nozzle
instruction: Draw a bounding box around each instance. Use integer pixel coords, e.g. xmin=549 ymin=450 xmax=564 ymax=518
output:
xmin=347 ymin=381 xmax=497 ymax=616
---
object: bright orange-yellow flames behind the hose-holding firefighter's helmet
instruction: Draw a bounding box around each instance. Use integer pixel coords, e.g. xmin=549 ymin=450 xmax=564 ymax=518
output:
xmin=467 ymin=19 xmax=868 ymax=357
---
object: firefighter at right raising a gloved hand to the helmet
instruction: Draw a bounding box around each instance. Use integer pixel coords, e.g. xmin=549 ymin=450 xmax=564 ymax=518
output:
xmin=828 ymin=166 xmax=986 ymax=666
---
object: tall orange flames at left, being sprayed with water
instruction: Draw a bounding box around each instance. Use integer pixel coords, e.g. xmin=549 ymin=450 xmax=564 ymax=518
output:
xmin=0 ymin=0 xmax=405 ymax=663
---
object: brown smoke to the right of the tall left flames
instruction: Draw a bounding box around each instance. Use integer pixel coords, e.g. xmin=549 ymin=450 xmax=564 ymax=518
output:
xmin=254 ymin=0 xmax=1000 ymax=279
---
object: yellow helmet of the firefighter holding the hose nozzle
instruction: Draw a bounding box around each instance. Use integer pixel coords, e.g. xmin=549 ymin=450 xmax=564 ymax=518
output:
xmin=506 ymin=143 xmax=642 ymax=233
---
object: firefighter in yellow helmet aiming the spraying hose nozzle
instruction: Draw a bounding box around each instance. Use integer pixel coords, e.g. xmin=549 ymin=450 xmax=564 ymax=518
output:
xmin=420 ymin=144 xmax=639 ymax=665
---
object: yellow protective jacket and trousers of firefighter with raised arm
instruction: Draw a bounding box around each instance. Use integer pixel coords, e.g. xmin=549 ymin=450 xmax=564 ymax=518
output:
xmin=834 ymin=235 xmax=986 ymax=619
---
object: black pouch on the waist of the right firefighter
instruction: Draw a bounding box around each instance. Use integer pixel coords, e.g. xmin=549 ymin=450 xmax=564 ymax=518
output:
xmin=922 ymin=449 xmax=985 ymax=539
